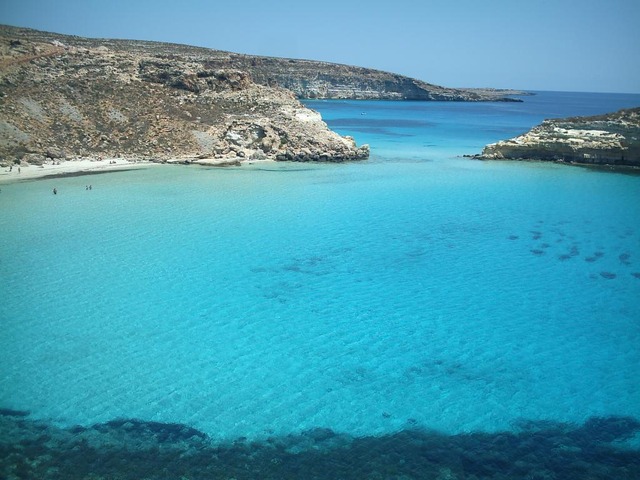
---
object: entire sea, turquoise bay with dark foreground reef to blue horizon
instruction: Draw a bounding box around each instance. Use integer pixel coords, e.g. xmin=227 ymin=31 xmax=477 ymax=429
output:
xmin=0 ymin=92 xmax=640 ymax=480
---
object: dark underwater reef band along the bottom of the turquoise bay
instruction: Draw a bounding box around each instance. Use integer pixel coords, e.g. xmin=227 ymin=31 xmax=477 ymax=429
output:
xmin=0 ymin=409 xmax=640 ymax=480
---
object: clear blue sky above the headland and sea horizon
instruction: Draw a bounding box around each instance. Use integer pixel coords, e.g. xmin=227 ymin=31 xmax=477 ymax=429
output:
xmin=0 ymin=0 xmax=640 ymax=93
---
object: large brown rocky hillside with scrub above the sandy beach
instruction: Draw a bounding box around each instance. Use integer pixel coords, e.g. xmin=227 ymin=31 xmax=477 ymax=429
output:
xmin=0 ymin=27 xmax=369 ymax=164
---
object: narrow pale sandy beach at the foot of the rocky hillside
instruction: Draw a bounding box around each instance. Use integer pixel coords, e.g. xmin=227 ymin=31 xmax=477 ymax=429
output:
xmin=0 ymin=158 xmax=275 ymax=185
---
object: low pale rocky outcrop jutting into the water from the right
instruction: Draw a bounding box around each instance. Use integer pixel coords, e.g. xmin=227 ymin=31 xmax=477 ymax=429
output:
xmin=478 ymin=108 xmax=640 ymax=166
